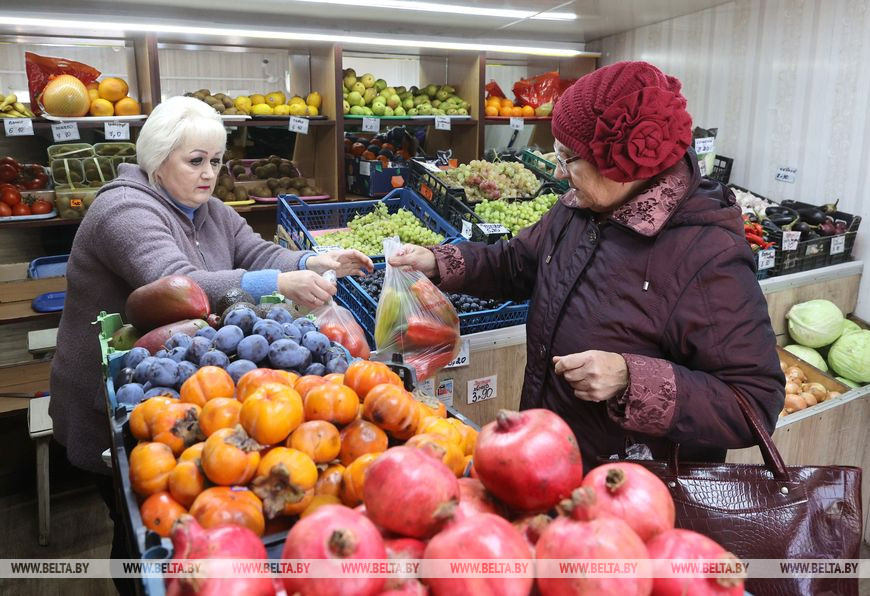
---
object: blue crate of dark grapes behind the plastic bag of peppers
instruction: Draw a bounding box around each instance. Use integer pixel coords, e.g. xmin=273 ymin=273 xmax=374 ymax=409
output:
xmin=335 ymin=263 xmax=529 ymax=349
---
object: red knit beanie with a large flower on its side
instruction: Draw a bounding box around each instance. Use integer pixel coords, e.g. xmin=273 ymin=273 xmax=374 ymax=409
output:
xmin=553 ymin=62 xmax=692 ymax=182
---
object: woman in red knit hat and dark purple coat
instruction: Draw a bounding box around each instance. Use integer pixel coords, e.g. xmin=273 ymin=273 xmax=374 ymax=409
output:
xmin=392 ymin=62 xmax=784 ymax=468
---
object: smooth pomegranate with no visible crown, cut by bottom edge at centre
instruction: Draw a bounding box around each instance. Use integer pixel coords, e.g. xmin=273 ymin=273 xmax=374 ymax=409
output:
xmin=423 ymin=513 xmax=534 ymax=596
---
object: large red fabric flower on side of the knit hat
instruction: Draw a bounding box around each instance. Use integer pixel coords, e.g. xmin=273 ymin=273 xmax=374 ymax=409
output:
xmin=590 ymin=87 xmax=692 ymax=182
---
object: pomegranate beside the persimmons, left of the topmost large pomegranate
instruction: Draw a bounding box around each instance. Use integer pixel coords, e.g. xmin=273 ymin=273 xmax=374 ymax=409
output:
xmin=363 ymin=447 xmax=459 ymax=538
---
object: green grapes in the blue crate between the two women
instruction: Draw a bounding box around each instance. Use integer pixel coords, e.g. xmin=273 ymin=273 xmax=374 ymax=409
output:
xmin=317 ymin=203 xmax=444 ymax=255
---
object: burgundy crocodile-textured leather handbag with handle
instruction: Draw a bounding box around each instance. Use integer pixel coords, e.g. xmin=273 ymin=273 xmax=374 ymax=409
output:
xmin=634 ymin=387 xmax=863 ymax=596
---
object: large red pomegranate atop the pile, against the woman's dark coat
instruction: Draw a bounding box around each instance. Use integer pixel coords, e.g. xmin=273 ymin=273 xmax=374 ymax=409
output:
xmin=474 ymin=409 xmax=583 ymax=511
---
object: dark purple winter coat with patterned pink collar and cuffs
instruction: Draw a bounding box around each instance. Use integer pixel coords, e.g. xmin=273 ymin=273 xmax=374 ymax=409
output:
xmin=433 ymin=155 xmax=785 ymax=468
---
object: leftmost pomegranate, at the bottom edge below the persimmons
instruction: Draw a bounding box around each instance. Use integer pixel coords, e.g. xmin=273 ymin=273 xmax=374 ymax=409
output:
xmin=166 ymin=514 xmax=272 ymax=596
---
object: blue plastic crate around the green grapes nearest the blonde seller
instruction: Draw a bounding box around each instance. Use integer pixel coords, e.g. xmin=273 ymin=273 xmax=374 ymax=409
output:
xmin=278 ymin=188 xmax=460 ymax=262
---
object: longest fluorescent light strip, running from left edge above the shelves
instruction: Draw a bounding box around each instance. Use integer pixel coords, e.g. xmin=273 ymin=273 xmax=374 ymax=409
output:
xmin=0 ymin=13 xmax=584 ymax=58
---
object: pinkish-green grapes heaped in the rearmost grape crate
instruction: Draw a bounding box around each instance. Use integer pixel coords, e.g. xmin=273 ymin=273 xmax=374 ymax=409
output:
xmin=439 ymin=159 xmax=539 ymax=203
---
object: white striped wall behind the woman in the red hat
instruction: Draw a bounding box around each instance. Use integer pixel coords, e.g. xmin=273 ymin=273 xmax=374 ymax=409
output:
xmin=587 ymin=0 xmax=870 ymax=319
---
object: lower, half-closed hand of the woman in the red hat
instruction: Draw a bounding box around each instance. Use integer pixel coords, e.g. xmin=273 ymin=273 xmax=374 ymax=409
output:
xmin=553 ymin=350 xmax=628 ymax=401
